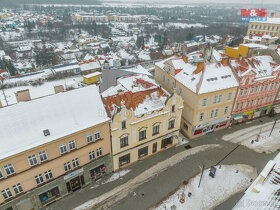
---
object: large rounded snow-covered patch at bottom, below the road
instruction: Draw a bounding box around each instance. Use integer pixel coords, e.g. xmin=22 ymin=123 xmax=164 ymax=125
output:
xmin=156 ymin=164 xmax=257 ymax=210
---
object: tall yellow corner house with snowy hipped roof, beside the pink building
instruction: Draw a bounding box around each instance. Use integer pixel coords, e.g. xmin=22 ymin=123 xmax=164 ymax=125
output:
xmin=155 ymin=56 xmax=239 ymax=138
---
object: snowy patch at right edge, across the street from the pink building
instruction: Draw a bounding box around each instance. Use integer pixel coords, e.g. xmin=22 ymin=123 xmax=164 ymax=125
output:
xmin=222 ymin=121 xmax=280 ymax=153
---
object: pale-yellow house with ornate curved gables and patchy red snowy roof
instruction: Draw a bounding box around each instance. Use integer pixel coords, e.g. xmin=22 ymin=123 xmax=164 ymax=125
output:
xmin=102 ymin=75 xmax=183 ymax=171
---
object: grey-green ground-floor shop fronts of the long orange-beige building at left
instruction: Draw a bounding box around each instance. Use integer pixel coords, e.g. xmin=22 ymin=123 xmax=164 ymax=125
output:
xmin=0 ymin=154 xmax=113 ymax=210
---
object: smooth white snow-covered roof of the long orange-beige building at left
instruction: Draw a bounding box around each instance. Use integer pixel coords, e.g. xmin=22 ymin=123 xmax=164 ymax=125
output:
xmin=0 ymin=85 xmax=109 ymax=159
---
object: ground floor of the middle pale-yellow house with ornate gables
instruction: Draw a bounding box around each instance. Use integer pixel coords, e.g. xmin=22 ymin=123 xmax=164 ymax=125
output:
xmin=113 ymin=130 xmax=179 ymax=171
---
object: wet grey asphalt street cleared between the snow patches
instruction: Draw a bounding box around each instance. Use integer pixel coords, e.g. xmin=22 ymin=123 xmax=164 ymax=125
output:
xmin=48 ymin=118 xmax=277 ymax=210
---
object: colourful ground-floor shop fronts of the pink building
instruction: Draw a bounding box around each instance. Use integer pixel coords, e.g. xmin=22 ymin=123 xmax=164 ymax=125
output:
xmin=232 ymin=106 xmax=273 ymax=124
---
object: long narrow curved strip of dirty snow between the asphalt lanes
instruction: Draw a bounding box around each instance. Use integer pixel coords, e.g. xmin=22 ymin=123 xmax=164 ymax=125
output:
xmin=74 ymin=144 xmax=222 ymax=210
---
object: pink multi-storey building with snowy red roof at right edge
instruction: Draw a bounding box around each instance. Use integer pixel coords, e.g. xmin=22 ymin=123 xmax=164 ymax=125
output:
xmin=231 ymin=56 xmax=280 ymax=123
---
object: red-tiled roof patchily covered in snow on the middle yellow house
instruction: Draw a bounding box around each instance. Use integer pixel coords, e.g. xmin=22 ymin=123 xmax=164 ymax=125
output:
xmin=102 ymin=75 xmax=168 ymax=117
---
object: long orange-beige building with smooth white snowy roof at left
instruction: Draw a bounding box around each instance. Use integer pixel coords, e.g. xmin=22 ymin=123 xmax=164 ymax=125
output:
xmin=0 ymin=86 xmax=112 ymax=209
